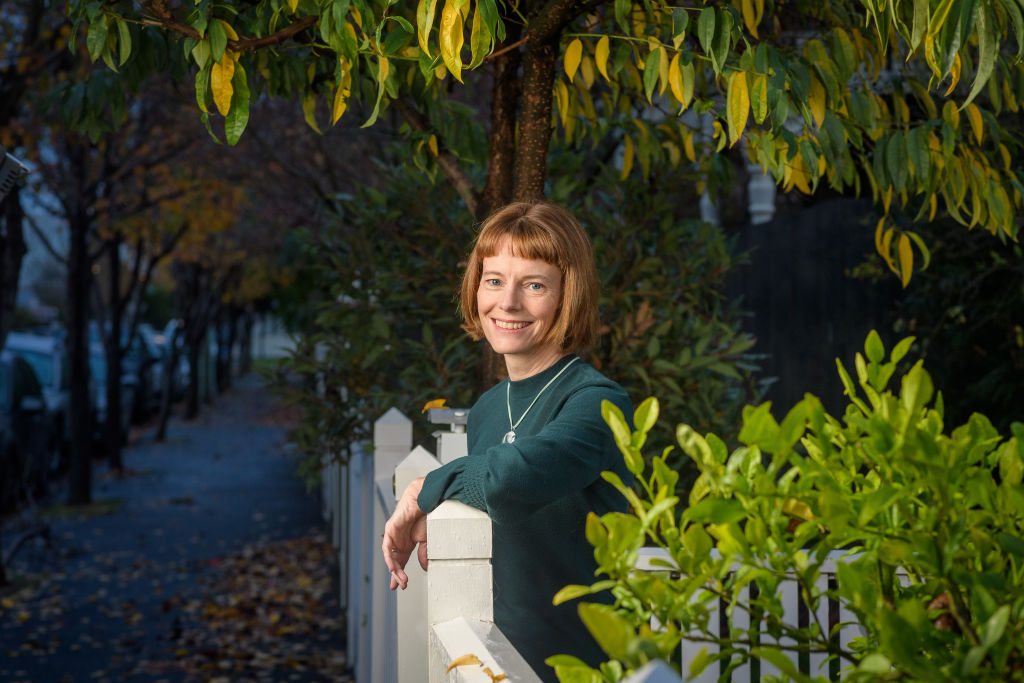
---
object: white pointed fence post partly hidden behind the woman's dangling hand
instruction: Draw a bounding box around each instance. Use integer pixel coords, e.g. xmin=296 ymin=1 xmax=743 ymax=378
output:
xmin=394 ymin=445 xmax=440 ymax=683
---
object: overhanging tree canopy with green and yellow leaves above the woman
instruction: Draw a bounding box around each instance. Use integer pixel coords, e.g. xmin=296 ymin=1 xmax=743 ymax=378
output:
xmin=70 ymin=0 xmax=1024 ymax=284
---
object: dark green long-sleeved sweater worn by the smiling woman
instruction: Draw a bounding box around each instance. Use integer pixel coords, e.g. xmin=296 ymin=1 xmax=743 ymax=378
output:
xmin=418 ymin=355 xmax=633 ymax=680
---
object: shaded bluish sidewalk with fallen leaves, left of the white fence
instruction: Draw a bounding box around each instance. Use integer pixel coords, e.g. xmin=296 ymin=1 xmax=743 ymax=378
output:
xmin=0 ymin=375 xmax=346 ymax=683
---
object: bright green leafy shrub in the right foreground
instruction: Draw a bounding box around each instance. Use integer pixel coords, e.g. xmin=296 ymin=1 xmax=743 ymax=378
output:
xmin=550 ymin=332 xmax=1024 ymax=682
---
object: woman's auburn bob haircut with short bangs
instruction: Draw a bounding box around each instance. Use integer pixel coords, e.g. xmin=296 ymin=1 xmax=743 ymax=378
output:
xmin=461 ymin=202 xmax=599 ymax=353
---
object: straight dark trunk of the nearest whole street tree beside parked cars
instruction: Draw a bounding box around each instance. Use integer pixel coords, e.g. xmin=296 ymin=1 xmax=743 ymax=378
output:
xmin=68 ymin=144 xmax=92 ymax=505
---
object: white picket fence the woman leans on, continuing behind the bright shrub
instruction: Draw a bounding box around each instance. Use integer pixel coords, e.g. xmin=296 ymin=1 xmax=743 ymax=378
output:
xmin=322 ymin=409 xmax=861 ymax=683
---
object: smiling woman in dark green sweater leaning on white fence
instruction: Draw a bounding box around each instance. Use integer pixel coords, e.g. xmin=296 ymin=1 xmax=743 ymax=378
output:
xmin=382 ymin=203 xmax=632 ymax=680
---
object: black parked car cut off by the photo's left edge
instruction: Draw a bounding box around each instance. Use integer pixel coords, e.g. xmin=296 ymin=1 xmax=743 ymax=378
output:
xmin=0 ymin=350 xmax=54 ymax=512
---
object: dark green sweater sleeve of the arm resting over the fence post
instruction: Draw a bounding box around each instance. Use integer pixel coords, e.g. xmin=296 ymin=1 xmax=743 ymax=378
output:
xmin=417 ymin=386 xmax=632 ymax=523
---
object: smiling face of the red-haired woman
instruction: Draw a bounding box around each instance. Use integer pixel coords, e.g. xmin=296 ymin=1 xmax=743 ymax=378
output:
xmin=476 ymin=240 xmax=562 ymax=380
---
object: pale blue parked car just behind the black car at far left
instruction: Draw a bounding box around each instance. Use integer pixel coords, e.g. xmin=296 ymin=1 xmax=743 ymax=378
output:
xmin=5 ymin=332 xmax=71 ymax=473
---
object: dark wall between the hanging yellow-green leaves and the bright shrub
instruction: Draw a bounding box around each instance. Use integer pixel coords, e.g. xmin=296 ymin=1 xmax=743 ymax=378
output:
xmin=729 ymin=199 xmax=899 ymax=419
